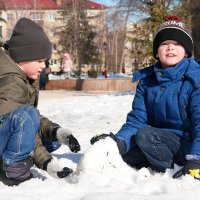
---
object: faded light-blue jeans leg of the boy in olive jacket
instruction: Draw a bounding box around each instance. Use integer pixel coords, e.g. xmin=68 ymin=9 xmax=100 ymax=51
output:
xmin=0 ymin=106 xmax=40 ymax=164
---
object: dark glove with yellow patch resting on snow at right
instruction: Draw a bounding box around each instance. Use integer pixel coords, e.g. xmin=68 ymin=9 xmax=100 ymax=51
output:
xmin=173 ymin=160 xmax=200 ymax=180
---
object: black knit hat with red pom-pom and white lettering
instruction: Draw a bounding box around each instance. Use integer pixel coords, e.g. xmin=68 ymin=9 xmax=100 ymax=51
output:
xmin=153 ymin=16 xmax=193 ymax=59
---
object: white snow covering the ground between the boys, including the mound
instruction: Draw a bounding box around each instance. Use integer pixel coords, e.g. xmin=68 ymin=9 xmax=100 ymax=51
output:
xmin=0 ymin=91 xmax=200 ymax=200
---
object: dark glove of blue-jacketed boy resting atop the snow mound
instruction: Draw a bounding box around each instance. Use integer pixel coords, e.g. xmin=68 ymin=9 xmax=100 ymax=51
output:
xmin=90 ymin=133 xmax=126 ymax=154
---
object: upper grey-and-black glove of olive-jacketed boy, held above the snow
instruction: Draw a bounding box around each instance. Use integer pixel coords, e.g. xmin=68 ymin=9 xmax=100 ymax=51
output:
xmin=56 ymin=128 xmax=81 ymax=153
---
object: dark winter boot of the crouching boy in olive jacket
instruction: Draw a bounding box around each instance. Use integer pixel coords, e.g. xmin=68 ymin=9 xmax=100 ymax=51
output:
xmin=0 ymin=157 xmax=33 ymax=186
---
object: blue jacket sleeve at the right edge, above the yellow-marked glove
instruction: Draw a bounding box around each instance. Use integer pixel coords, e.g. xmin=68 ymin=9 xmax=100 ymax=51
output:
xmin=189 ymin=88 xmax=200 ymax=155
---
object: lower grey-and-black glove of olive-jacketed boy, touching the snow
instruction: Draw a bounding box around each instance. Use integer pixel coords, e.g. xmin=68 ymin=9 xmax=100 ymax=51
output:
xmin=43 ymin=158 xmax=73 ymax=178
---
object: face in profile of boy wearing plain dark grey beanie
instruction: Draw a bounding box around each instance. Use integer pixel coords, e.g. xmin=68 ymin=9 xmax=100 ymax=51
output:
xmin=18 ymin=59 xmax=46 ymax=80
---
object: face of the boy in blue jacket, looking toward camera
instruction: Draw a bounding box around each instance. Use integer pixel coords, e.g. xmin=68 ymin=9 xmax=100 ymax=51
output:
xmin=156 ymin=40 xmax=187 ymax=68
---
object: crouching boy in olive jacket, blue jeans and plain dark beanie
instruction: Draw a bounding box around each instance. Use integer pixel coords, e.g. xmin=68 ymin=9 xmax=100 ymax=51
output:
xmin=0 ymin=18 xmax=80 ymax=186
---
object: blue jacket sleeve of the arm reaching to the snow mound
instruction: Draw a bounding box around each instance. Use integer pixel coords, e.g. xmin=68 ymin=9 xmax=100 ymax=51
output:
xmin=116 ymin=81 xmax=147 ymax=152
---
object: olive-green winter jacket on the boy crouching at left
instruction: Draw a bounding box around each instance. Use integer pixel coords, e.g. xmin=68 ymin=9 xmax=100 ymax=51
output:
xmin=0 ymin=48 xmax=59 ymax=168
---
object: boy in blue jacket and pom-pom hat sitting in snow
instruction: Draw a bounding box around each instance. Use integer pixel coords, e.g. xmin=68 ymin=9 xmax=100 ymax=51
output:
xmin=91 ymin=16 xmax=200 ymax=179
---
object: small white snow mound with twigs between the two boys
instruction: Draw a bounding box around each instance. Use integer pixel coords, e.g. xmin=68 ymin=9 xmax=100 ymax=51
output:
xmin=78 ymin=137 xmax=133 ymax=182
